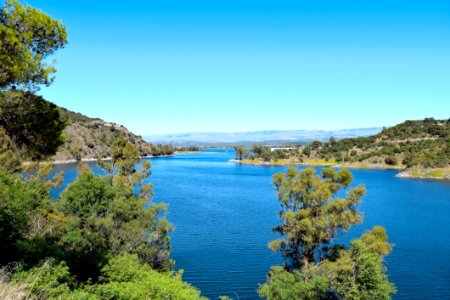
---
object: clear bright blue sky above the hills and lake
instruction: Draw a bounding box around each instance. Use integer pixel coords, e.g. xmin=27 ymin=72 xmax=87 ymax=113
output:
xmin=27 ymin=0 xmax=450 ymax=135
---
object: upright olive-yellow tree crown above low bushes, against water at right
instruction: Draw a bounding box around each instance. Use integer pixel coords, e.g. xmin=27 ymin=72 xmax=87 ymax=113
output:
xmin=270 ymin=168 xmax=365 ymax=270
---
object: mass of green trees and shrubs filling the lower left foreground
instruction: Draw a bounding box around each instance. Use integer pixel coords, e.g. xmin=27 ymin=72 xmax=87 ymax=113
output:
xmin=0 ymin=146 xmax=204 ymax=299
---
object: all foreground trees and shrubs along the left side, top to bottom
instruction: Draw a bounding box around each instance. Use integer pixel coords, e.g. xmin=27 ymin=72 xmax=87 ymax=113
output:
xmin=0 ymin=0 xmax=201 ymax=299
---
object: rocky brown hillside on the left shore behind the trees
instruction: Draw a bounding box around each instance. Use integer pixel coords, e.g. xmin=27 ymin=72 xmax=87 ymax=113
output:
xmin=53 ymin=108 xmax=173 ymax=161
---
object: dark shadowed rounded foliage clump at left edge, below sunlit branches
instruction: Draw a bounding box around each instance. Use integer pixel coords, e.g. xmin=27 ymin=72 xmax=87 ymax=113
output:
xmin=0 ymin=91 xmax=66 ymax=160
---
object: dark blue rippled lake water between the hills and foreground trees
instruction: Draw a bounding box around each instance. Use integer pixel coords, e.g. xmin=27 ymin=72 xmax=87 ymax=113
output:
xmin=53 ymin=150 xmax=450 ymax=299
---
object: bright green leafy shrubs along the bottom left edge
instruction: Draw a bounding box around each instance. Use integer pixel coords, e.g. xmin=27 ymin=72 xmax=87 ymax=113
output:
xmin=12 ymin=254 xmax=205 ymax=300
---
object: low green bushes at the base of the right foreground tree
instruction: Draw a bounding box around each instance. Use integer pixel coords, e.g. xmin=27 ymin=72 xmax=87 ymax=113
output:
xmin=259 ymin=227 xmax=395 ymax=300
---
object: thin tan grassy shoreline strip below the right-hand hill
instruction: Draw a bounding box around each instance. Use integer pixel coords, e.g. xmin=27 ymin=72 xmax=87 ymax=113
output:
xmin=228 ymin=159 xmax=450 ymax=180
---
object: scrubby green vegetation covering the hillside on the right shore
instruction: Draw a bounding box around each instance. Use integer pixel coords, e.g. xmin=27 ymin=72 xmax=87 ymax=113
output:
xmin=305 ymin=118 xmax=450 ymax=168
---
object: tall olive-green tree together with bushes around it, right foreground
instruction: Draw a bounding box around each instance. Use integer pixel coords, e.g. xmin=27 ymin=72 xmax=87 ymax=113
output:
xmin=259 ymin=168 xmax=395 ymax=300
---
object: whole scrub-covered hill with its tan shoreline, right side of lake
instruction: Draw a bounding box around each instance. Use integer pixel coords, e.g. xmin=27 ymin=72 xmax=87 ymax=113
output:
xmin=237 ymin=118 xmax=450 ymax=179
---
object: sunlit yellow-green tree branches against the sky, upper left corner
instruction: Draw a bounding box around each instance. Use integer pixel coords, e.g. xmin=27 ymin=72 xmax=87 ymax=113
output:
xmin=0 ymin=0 xmax=67 ymax=90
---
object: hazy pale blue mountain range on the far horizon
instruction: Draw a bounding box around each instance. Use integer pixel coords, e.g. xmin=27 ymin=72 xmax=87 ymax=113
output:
xmin=144 ymin=127 xmax=382 ymax=146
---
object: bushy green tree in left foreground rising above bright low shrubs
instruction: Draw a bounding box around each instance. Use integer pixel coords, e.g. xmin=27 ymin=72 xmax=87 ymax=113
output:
xmin=60 ymin=140 xmax=172 ymax=279
